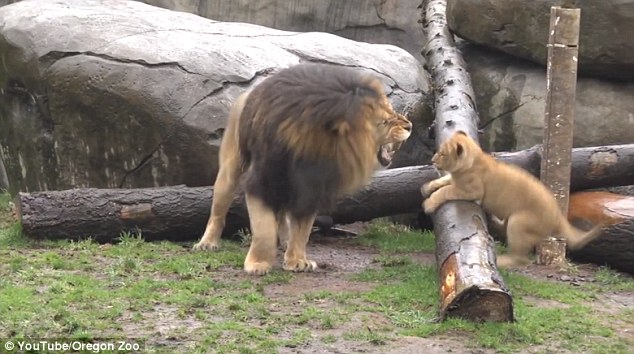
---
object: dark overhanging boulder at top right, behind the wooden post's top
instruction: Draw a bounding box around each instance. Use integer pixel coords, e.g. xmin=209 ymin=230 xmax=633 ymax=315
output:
xmin=447 ymin=0 xmax=634 ymax=80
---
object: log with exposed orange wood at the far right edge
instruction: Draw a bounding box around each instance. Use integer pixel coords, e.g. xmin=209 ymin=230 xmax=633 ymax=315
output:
xmin=568 ymin=191 xmax=634 ymax=274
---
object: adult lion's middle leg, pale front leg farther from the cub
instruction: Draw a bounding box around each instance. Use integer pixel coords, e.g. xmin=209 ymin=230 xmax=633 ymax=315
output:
xmin=244 ymin=194 xmax=278 ymax=275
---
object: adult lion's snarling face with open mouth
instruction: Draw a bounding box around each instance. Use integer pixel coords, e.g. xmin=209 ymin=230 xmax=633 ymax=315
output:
xmin=373 ymin=97 xmax=412 ymax=166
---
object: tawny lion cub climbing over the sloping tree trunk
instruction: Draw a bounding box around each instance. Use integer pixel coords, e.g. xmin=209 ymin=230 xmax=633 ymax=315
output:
xmin=421 ymin=131 xmax=601 ymax=267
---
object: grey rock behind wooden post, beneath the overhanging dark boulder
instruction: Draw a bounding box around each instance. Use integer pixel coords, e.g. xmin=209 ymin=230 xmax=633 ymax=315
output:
xmin=462 ymin=44 xmax=634 ymax=151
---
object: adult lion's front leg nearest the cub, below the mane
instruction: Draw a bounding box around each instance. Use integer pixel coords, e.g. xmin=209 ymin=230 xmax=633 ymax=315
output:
xmin=283 ymin=215 xmax=317 ymax=272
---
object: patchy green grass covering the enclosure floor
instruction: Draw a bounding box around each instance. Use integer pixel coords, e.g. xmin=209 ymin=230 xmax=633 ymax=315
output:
xmin=0 ymin=194 xmax=634 ymax=353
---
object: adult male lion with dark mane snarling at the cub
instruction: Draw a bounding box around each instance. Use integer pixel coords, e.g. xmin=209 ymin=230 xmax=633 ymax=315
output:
xmin=194 ymin=64 xmax=412 ymax=274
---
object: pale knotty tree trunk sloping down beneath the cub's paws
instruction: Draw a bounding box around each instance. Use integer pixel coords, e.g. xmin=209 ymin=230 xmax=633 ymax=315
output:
xmin=422 ymin=0 xmax=513 ymax=321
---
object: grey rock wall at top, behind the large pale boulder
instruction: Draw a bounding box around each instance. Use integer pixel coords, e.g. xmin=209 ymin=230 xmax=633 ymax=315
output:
xmin=140 ymin=0 xmax=424 ymax=59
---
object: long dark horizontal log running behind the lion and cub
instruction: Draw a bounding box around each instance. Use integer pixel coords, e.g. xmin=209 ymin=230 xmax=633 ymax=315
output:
xmin=15 ymin=144 xmax=634 ymax=242
